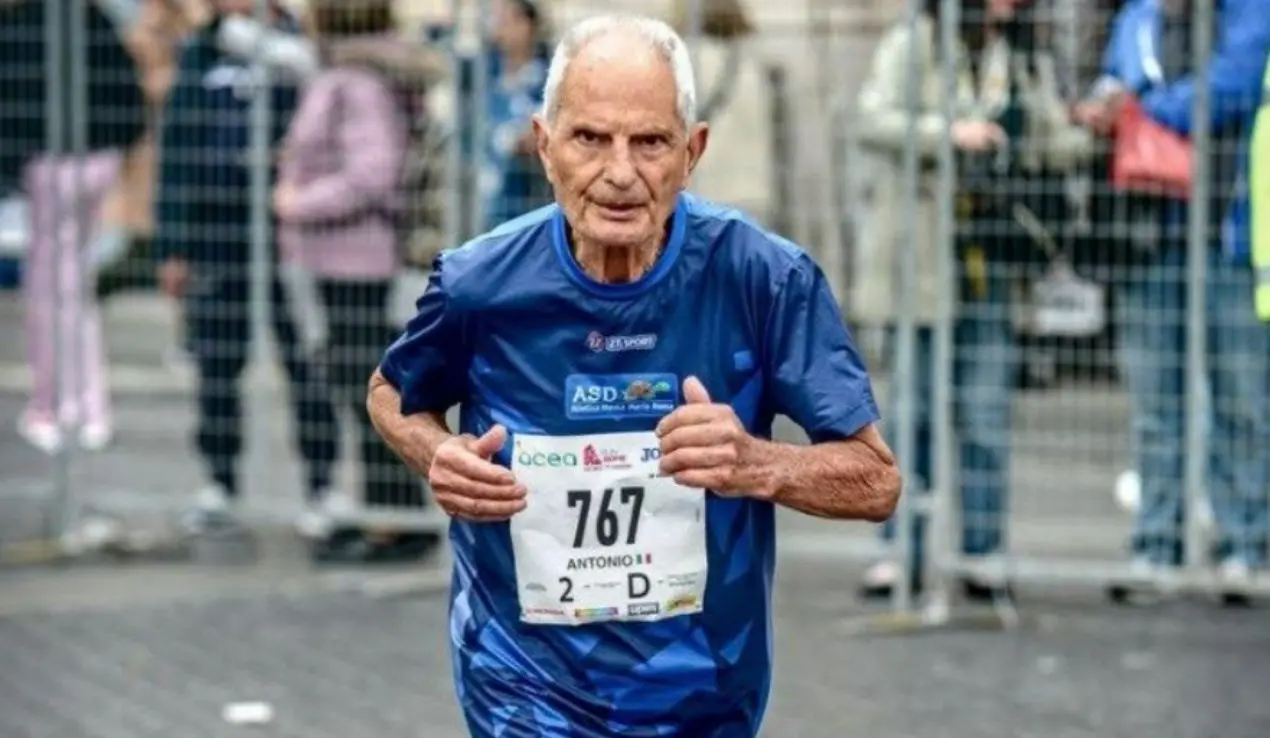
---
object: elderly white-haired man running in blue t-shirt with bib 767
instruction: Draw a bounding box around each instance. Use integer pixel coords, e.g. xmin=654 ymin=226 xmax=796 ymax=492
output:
xmin=368 ymin=12 xmax=900 ymax=738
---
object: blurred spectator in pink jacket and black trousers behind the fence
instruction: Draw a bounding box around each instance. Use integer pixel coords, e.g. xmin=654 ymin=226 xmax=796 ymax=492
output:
xmin=273 ymin=0 xmax=445 ymax=561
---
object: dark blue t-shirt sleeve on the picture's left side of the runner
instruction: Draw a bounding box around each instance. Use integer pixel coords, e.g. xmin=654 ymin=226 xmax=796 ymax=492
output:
xmin=380 ymin=257 xmax=471 ymax=415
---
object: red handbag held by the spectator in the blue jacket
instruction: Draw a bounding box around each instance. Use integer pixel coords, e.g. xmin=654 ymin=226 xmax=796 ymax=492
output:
xmin=1111 ymin=98 xmax=1194 ymax=199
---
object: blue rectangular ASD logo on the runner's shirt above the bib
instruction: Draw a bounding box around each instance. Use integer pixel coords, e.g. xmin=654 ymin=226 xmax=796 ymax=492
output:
xmin=564 ymin=373 xmax=679 ymax=420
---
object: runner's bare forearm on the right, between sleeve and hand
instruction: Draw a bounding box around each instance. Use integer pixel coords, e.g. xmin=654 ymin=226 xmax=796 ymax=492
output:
xmin=737 ymin=426 xmax=900 ymax=522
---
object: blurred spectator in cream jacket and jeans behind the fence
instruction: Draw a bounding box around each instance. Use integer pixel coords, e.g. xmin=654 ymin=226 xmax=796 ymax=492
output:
xmin=852 ymin=0 xmax=1088 ymax=598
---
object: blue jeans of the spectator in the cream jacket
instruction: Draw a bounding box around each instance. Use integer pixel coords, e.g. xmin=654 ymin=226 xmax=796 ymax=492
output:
xmin=881 ymin=277 xmax=1017 ymax=574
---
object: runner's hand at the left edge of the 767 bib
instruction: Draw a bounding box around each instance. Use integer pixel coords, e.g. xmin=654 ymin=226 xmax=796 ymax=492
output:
xmin=428 ymin=426 xmax=527 ymax=522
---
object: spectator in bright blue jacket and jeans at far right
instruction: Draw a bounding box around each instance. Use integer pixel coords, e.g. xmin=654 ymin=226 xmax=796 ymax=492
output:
xmin=1076 ymin=0 xmax=1270 ymax=601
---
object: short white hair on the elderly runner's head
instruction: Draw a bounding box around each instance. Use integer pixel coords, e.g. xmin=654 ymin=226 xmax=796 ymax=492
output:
xmin=542 ymin=15 xmax=697 ymax=126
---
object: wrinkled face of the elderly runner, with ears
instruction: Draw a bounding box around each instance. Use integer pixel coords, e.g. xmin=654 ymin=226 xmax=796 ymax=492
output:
xmin=533 ymin=36 xmax=707 ymax=256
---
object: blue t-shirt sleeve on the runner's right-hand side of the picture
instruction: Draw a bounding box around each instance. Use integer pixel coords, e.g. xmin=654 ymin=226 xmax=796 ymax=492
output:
xmin=765 ymin=257 xmax=879 ymax=443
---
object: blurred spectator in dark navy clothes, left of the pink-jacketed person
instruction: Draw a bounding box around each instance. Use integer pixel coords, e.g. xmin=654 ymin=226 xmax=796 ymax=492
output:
xmin=155 ymin=0 xmax=335 ymax=530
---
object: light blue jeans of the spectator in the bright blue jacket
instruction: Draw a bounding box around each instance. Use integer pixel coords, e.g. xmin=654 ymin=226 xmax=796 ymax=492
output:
xmin=1118 ymin=246 xmax=1270 ymax=567
